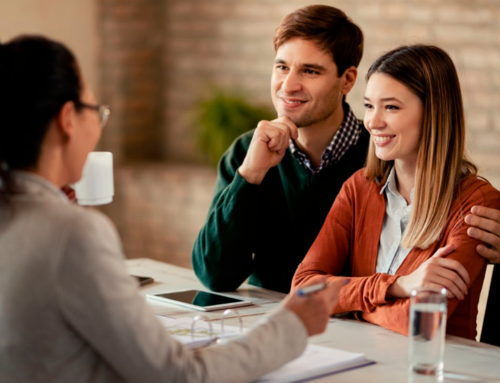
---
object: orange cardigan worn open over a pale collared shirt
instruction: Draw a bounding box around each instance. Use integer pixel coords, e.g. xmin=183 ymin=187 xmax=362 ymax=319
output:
xmin=292 ymin=169 xmax=500 ymax=339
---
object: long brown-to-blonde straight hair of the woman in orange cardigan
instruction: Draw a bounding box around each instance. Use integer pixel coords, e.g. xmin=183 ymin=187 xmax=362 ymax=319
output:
xmin=365 ymin=44 xmax=477 ymax=249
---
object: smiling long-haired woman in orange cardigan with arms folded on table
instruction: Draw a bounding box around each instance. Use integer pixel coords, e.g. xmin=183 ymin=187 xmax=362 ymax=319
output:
xmin=292 ymin=45 xmax=500 ymax=339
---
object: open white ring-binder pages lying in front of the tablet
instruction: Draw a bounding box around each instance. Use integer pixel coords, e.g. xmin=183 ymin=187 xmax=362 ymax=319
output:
xmin=156 ymin=315 xmax=240 ymax=348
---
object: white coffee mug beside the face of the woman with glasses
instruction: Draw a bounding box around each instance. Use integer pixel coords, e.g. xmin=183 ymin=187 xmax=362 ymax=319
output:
xmin=75 ymin=152 xmax=115 ymax=206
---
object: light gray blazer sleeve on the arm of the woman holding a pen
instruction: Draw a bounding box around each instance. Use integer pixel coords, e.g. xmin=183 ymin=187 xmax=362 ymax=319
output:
xmin=56 ymin=210 xmax=307 ymax=383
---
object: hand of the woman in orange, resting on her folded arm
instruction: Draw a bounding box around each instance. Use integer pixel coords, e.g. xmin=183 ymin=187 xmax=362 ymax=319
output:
xmin=387 ymin=245 xmax=470 ymax=300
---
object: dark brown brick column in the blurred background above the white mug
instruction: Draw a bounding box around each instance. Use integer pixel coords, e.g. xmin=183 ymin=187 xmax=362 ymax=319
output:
xmin=99 ymin=0 xmax=164 ymax=162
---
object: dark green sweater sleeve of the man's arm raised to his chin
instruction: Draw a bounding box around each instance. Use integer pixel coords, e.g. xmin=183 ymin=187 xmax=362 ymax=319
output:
xmin=192 ymin=134 xmax=260 ymax=291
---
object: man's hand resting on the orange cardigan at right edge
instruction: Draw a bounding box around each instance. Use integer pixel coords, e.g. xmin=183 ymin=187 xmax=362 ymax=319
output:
xmin=465 ymin=206 xmax=500 ymax=263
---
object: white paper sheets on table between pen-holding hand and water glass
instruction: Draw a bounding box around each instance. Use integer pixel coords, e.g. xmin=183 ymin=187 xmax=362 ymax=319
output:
xmin=257 ymin=344 xmax=375 ymax=383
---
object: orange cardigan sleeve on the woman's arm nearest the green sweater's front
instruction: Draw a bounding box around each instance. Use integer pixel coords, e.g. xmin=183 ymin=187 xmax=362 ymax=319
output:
xmin=292 ymin=175 xmax=397 ymax=314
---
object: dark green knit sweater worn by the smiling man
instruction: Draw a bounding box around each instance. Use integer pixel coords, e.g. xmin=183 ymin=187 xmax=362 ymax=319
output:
xmin=192 ymin=129 xmax=369 ymax=292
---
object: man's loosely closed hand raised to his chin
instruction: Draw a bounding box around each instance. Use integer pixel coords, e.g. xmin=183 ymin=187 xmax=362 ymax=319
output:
xmin=238 ymin=116 xmax=299 ymax=185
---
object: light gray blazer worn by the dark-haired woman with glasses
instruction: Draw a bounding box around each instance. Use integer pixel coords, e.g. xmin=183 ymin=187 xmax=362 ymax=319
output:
xmin=0 ymin=172 xmax=307 ymax=383
